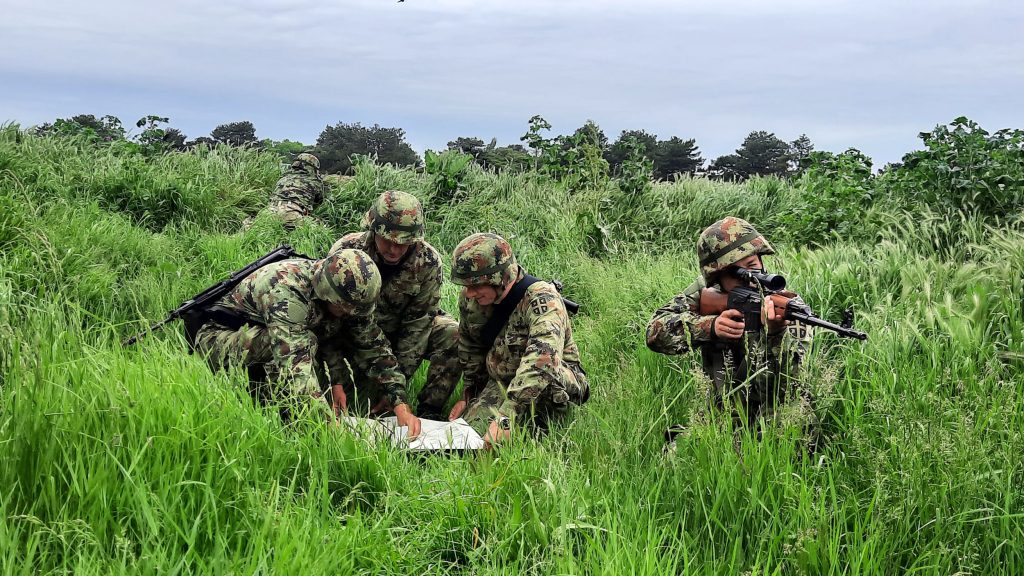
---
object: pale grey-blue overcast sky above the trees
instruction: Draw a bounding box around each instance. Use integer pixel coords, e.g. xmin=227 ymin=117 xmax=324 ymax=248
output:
xmin=0 ymin=0 xmax=1024 ymax=166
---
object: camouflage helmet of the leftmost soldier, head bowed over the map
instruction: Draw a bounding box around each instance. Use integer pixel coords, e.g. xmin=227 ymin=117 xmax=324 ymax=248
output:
xmin=313 ymin=248 xmax=381 ymax=316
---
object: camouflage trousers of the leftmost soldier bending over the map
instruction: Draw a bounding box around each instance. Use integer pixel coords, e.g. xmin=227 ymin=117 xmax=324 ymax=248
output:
xmin=196 ymin=322 xmax=321 ymax=404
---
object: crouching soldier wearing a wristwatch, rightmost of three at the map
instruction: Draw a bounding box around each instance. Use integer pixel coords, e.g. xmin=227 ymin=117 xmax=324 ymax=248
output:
xmin=450 ymin=234 xmax=590 ymax=444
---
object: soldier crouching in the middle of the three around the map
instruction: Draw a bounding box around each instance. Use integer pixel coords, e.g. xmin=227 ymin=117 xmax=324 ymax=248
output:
xmin=331 ymin=191 xmax=462 ymax=420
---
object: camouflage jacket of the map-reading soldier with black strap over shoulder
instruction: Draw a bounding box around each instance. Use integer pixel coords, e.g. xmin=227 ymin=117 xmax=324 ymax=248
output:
xmin=459 ymin=268 xmax=587 ymax=416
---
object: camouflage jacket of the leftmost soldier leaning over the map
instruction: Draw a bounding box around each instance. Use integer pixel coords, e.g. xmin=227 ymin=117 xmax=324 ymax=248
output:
xmin=208 ymin=259 xmax=407 ymax=406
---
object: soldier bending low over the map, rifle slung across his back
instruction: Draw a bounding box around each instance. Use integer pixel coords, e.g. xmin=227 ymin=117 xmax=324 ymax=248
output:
xmin=196 ymin=250 xmax=420 ymax=436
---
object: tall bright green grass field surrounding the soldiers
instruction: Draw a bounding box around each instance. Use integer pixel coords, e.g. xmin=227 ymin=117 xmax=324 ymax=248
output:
xmin=0 ymin=126 xmax=1024 ymax=574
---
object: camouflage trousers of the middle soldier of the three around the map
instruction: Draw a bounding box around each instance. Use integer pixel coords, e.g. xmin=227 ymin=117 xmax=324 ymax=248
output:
xmin=329 ymin=315 xmax=462 ymax=416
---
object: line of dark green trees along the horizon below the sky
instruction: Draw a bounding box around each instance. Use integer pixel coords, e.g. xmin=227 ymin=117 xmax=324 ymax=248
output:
xmin=36 ymin=109 xmax=814 ymax=180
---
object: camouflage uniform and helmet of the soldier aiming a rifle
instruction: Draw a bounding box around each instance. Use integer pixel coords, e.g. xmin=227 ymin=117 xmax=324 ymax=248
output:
xmin=647 ymin=217 xmax=810 ymax=424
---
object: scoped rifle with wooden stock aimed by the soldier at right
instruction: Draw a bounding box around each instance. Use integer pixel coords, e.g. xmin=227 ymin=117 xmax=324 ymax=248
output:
xmin=700 ymin=269 xmax=867 ymax=340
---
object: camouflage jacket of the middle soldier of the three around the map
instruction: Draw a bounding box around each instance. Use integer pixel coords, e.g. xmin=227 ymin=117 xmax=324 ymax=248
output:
xmin=331 ymin=232 xmax=443 ymax=380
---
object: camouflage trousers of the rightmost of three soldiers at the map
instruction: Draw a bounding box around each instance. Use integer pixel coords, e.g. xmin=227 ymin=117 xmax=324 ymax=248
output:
xmin=463 ymin=356 xmax=590 ymax=436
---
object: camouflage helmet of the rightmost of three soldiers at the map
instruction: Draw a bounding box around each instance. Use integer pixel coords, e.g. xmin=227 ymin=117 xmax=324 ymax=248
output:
xmin=452 ymin=233 xmax=519 ymax=286
